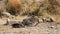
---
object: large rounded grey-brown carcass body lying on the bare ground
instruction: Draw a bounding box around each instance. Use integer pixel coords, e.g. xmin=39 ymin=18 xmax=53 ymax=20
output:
xmin=22 ymin=16 xmax=39 ymax=26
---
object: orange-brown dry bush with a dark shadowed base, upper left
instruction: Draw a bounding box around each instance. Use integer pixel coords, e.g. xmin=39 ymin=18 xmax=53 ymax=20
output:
xmin=7 ymin=0 xmax=23 ymax=15
